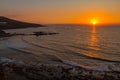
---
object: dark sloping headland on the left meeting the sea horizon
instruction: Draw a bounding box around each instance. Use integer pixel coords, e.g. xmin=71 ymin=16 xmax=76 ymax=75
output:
xmin=0 ymin=16 xmax=43 ymax=29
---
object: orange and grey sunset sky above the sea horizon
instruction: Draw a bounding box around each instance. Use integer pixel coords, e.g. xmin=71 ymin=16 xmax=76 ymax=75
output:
xmin=0 ymin=0 xmax=120 ymax=24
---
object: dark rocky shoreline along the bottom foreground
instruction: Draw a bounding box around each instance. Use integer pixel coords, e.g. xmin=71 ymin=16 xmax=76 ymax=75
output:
xmin=0 ymin=58 xmax=120 ymax=80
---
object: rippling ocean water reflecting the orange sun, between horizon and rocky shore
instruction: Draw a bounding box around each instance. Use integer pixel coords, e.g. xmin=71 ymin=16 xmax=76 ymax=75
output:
xmin=5 ymin=25 xmax=120 ymax=71
